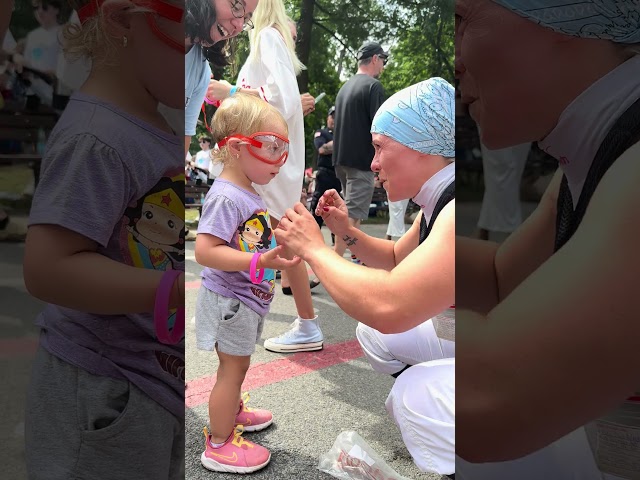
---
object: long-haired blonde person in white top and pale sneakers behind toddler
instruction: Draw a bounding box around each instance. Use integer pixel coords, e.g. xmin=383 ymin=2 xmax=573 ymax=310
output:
xmin=209 ymin=0 xmax=323 ymax=353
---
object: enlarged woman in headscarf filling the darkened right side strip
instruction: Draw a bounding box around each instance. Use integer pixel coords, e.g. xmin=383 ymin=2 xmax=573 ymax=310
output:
xmin=456 ymin=0 xmax=640 ymax=480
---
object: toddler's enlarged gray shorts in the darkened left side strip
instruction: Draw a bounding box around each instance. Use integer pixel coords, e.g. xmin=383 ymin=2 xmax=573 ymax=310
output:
xmin=25 ymin=347 xmax=185 ymax=480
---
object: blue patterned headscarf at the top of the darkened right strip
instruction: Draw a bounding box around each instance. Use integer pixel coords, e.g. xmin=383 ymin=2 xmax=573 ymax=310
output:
xmin=493 ymin=0 xmax=640 ymax=43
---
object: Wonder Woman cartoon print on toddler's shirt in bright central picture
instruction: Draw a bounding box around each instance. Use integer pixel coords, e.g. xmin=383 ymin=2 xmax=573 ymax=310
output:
xmin=237 ymin=210 xmax=277 ymax=301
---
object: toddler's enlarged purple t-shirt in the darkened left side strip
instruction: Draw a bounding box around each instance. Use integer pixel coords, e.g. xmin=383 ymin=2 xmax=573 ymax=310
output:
xmin=29 ymin=94 xmax=185 ymax=418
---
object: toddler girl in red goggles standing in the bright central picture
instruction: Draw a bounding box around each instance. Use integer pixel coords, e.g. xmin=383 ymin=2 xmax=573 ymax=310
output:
xmin=195 ymin=93 xmax=300 ymax=473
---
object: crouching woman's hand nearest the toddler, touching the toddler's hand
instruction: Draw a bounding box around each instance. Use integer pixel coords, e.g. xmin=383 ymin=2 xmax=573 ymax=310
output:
xmin=275 ymin=203 xmax=325 ymax=258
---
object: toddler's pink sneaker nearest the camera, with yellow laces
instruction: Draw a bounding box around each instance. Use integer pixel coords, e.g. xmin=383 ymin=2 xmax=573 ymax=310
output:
xmin=200 ymin=427 xmax=271 ymax=473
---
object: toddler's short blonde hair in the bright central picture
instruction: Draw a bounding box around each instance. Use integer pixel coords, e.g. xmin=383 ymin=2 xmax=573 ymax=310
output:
xmin=211 ymin=93 xmax=289 ymax=164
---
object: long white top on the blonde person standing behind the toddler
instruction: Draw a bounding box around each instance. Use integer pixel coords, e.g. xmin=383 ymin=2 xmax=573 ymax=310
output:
xmin=236 ymin=27 xmax=305 ymax=220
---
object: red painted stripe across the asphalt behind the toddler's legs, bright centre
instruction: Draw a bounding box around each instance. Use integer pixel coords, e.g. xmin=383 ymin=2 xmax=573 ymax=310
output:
xmin=184 ymin=339 xmax=363 ymax=408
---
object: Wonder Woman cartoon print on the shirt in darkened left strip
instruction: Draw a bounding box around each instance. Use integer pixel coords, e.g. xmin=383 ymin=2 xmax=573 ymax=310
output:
xmin=121 ymin=169 xmax=185 ymax=380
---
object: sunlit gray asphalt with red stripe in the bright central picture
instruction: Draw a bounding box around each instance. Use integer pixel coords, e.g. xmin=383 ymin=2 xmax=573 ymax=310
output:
xmin=186 ymin=224 xmax=441 ymax=480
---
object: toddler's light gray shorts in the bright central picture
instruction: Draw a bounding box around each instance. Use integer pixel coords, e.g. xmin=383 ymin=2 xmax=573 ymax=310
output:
xmin=196 ymin=285 xmax=264 ymax=357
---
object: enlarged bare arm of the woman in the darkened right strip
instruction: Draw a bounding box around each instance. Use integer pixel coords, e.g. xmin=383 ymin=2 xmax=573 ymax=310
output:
xmin=456 ymin=146 xmax=640 ymax=462
